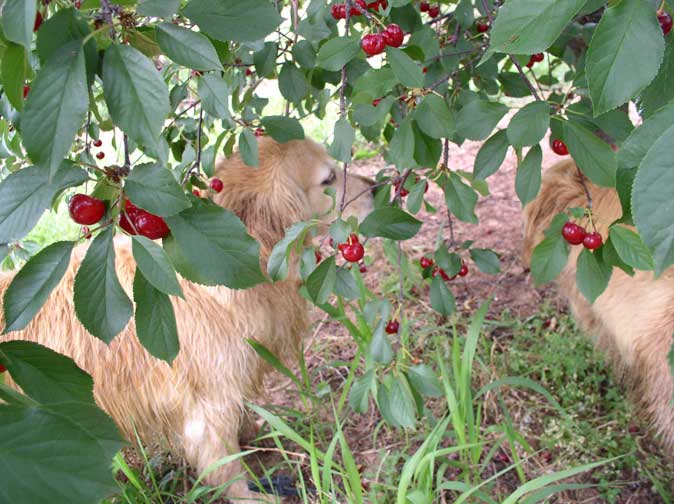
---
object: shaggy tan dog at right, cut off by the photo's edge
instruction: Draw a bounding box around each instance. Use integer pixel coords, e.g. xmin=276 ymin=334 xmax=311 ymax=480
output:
xmin=524 ymin=160 xmax=674 ymax=452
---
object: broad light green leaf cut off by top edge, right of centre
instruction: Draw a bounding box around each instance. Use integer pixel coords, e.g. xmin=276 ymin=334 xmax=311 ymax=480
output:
xmin=490 ymin=0 xmax=586 ymax=54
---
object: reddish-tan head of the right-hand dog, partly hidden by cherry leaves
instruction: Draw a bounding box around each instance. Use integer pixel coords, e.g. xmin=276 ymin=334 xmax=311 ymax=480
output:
xmin=523 ymin=159 xmax=622 ymax=266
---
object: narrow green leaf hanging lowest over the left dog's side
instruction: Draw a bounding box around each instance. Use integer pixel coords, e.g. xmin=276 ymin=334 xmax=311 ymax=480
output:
xmin=133 ymin=270 xmax=180 ymax=364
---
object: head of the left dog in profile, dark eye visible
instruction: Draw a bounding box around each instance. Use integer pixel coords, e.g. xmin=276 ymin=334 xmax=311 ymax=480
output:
xmin=214 ymin=138 xmax=374 ymax=257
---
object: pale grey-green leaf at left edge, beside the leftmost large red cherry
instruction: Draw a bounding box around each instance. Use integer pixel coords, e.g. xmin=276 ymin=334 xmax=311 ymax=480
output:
xmin=0 ymin=163 xmax=88 ymax=243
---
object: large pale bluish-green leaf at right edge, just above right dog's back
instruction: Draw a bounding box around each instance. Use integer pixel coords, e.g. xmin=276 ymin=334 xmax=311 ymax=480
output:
xmin=632 ymin=128 xmax=674 ymax=275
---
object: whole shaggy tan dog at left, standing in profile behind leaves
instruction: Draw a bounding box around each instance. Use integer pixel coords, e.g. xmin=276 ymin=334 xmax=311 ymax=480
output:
xmin=0 ymin=139 xmax=372 ymax=502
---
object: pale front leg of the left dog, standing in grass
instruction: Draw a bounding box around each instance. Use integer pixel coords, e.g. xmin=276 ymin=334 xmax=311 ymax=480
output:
xmin=182 ymin=405 xmax=275 ymax=504
